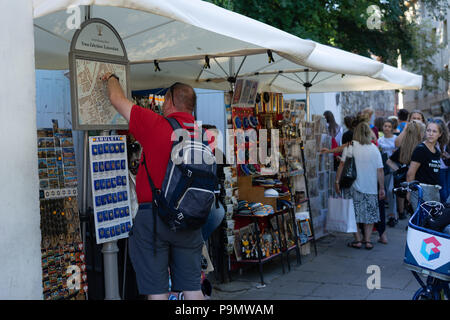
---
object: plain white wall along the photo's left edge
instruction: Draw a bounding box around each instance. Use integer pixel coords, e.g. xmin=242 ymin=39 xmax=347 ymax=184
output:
xmin=0 ymin=0 xmax=43 ymax=299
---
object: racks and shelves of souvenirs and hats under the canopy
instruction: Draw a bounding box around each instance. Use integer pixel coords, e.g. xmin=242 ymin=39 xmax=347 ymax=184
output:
xmin=215 ymin=79 xmax=334 ymax=285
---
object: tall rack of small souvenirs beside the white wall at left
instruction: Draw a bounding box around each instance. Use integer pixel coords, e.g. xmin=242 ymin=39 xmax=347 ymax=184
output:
xmin=37 ymin=123 xmax=88 ymax=300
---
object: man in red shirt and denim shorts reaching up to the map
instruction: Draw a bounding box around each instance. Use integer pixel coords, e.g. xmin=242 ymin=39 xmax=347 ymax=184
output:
xmin=102 ymin=73 xmax=203 ymax=300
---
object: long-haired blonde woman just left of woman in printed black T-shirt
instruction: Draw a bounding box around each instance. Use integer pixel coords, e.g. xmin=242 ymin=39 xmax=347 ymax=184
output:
xmin=386 ymin=122 xmax=425 ymax=220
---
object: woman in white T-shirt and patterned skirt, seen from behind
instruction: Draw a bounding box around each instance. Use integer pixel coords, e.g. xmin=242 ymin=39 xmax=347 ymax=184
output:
xmin=335 ymin=121 xmax=385 ymax=250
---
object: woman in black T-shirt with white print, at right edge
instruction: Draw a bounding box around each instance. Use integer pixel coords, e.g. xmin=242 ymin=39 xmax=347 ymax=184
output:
xmin=406 ymin=120 xmax=448 ymax=212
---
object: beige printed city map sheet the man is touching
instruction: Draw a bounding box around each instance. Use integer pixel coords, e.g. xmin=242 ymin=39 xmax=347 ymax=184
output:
xmin=76 ymin=59 xmax=127 ymax=125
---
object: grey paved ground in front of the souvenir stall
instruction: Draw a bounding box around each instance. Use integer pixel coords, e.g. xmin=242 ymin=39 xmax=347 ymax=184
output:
xmin=212 ymin=221 xmax=419 ymax=300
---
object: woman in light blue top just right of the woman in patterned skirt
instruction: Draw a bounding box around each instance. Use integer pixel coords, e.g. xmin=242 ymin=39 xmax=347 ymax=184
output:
xmin=378 ymin=119 xmax=397 ymax=229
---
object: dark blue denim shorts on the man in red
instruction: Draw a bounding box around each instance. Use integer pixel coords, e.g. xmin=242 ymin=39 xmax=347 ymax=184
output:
xmin=129 ymin=203 xmax=203 ymax=295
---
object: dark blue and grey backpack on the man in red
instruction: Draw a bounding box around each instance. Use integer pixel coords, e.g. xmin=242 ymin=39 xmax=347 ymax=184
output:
xmin=143 ymin=118 xmax=217 ymax=235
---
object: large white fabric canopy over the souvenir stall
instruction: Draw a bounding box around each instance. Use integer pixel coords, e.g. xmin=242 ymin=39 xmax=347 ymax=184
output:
xmin=33 ymin=0 xmax=422 ymax=93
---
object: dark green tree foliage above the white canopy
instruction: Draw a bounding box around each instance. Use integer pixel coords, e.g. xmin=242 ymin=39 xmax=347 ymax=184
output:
xmin=210 ymin=0 xmax=449 ymax=90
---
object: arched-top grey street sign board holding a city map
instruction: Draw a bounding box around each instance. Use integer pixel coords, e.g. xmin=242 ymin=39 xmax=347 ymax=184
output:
xmin=69 ymin=18 xmax=131 ymax=130
